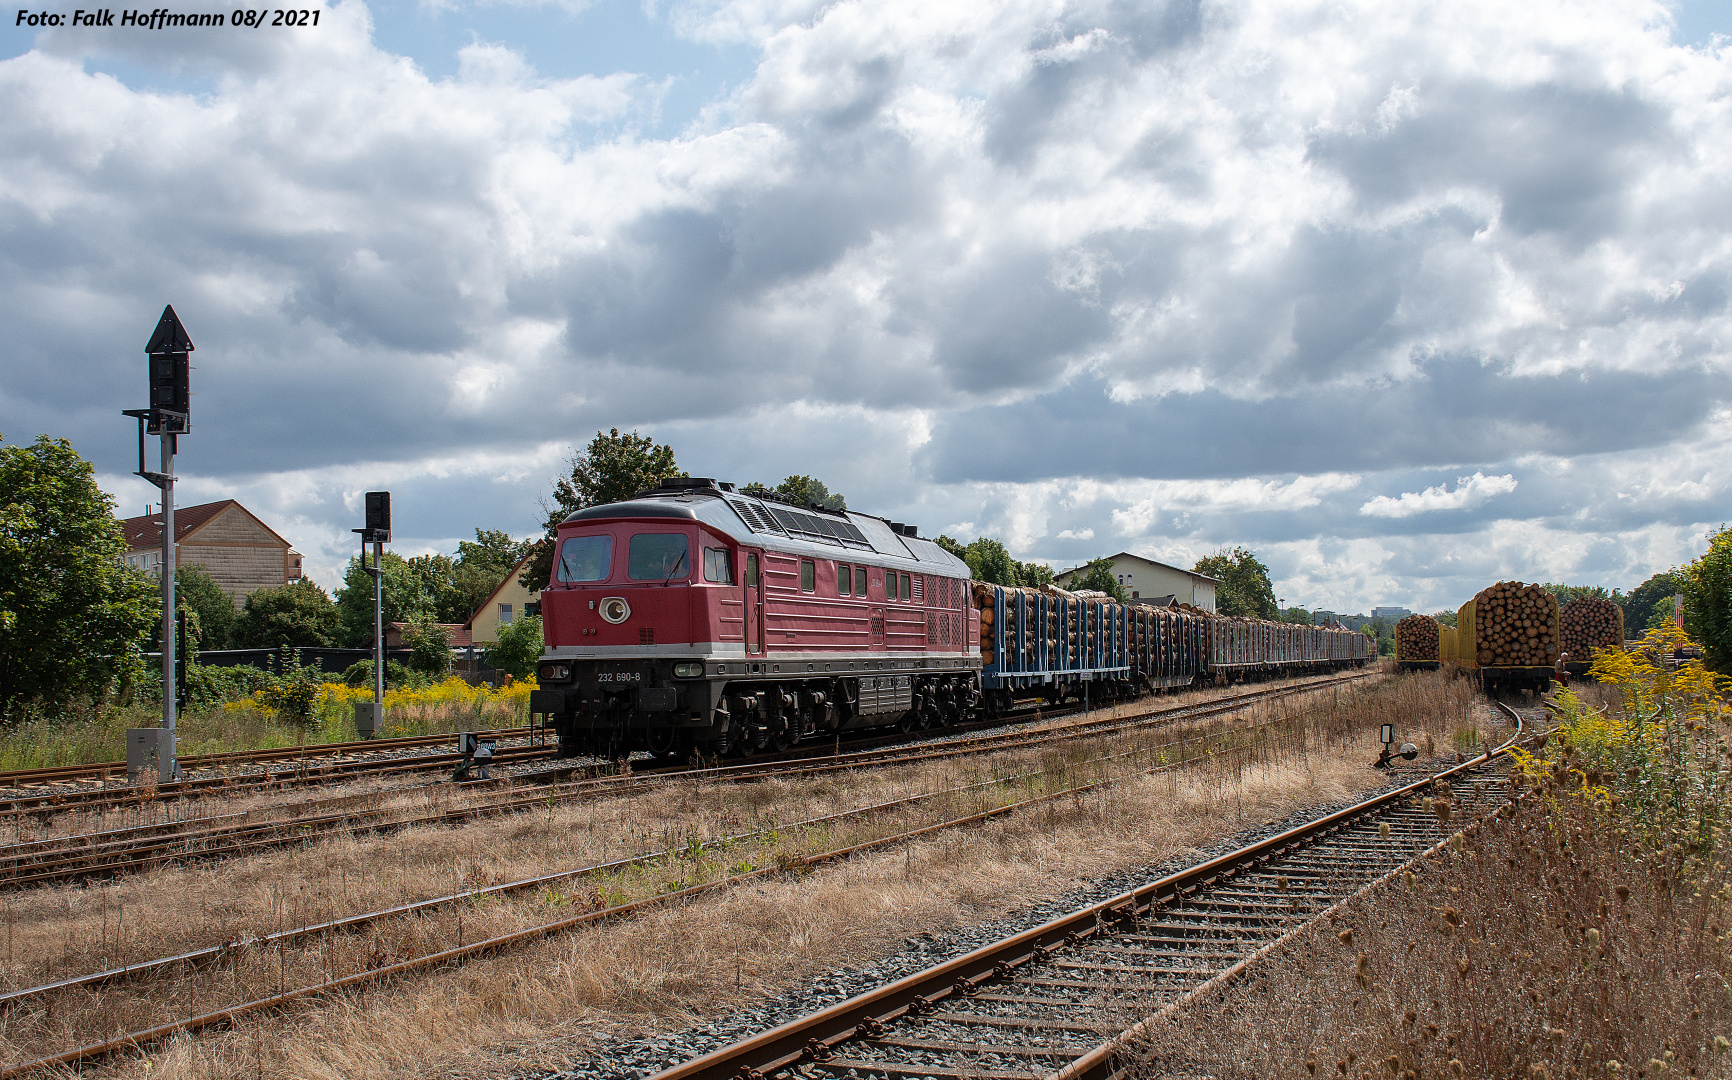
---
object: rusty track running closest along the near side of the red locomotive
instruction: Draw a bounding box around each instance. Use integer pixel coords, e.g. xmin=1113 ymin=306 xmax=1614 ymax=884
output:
xmin=0 ymin=673 xmax=1365 ymax=888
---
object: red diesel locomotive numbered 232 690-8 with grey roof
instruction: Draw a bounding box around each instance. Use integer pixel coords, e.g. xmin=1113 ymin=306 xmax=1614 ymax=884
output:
xmin=530 ymin=478 xmax=980 ymax=758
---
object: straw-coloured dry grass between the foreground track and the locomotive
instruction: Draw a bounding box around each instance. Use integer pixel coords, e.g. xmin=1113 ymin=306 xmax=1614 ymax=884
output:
xmin=0 ymin=677 xmax=1470 ymax=1078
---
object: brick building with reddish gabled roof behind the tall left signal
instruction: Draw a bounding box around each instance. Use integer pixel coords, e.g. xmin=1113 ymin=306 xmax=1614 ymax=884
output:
xmin=121 ymin=498 xmax=301 ymax=609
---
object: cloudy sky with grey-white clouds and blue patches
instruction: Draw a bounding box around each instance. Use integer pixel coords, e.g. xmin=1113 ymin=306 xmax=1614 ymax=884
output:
xmin=0 ymin=0 xmax=1732 ymax=611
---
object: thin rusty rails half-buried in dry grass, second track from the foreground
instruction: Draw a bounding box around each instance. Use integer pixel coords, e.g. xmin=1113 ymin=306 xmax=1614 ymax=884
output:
xmin=0 ymin=671 xmax=1406 ymax=1078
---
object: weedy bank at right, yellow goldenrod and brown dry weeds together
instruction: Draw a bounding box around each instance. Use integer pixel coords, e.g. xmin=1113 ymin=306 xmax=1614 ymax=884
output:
xmin=1140 ymin=630 xmax=1732 ymax=1080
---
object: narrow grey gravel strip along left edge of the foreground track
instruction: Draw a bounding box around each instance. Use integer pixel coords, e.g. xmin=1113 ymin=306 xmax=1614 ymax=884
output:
xmin=521 ymin=740 xmax=1517 ymax=1080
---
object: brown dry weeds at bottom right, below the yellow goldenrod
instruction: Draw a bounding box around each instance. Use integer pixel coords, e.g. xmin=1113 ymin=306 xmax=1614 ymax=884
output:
xmin=1114 ymin=747 xmax=1732 ymax=1080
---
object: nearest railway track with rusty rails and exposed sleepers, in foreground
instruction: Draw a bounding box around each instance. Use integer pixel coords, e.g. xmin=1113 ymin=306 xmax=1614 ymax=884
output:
xmin=653 ymin=704 xmax=1521 ymax=1080
